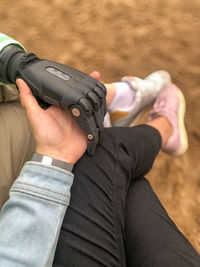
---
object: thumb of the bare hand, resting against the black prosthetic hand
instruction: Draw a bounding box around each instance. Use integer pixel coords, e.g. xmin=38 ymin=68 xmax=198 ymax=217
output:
xmin=16 ymin=79 xmax=41 ymax=113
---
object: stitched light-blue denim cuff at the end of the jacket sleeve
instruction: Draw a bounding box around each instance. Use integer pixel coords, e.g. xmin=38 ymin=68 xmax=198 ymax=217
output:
xmin=10 ymin=162 xmax=74 ymax=205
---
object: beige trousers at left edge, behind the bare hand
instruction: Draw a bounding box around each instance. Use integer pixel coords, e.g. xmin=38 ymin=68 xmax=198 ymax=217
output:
xmin=0 ymin=86 xmax=35 ymax=209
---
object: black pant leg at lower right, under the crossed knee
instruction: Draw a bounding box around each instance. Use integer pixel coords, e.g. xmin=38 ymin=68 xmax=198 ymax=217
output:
xmin=126 ymin=178 xmax=200 ymax=267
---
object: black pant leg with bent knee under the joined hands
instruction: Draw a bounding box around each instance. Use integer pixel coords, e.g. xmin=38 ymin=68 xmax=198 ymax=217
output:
xmin=54 ymin=125 xmax=161 ymax=267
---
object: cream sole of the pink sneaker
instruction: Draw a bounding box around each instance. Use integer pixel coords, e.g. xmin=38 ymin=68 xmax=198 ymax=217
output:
xmin=172 ymin=90 xmax=188 ymax=156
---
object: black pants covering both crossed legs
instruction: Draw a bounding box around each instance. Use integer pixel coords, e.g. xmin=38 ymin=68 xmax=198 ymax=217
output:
xmin=53 ymin=125 xmax=200 ymax=267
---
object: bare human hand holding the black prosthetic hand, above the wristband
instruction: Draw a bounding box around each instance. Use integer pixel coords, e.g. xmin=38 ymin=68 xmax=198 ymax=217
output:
xmin=16 ymin=79 xmax=87 ymax=164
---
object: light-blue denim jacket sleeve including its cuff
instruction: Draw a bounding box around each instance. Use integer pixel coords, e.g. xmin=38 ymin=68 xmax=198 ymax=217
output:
xmin=0 ymin=162 xmax=74 ymax=267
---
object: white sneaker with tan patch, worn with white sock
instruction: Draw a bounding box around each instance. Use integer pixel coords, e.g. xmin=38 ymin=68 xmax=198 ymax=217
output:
xmin=110 ymin=71 xmax=171 ymax=126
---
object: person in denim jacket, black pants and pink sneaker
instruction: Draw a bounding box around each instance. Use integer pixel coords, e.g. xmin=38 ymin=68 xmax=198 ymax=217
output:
xmin=0 ymin=71 xmax=200 ymax=266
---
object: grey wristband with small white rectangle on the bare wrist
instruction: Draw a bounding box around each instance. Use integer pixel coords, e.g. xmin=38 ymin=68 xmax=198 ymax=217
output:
xmin=31 ymin=153 xmax=74 ymax=172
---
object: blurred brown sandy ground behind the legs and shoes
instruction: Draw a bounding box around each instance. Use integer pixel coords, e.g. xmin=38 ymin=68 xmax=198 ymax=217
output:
xmin=0 ymin=0 xmax=200 ymax=255
